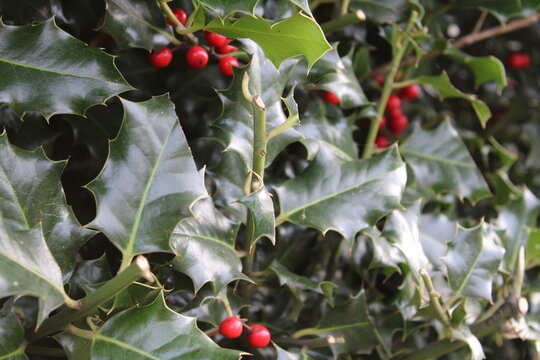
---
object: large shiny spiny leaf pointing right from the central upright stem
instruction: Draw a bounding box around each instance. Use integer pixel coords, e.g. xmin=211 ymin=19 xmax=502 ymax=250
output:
xmin=276 ymin=143 xmax=407 ymax=245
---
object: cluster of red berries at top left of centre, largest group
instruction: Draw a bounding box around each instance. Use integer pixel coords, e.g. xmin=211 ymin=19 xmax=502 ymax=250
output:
xmin=149 ymin=8 xmax=239 ymax=76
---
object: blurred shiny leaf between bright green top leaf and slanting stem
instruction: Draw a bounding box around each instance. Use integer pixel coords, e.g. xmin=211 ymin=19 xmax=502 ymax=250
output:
xmin=311 ymin=49 xmax=369 ymax=109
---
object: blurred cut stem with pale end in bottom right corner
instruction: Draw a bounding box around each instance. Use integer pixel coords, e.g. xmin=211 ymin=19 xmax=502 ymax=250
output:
xmin=398 ymin=297 xmax=528 ymax=360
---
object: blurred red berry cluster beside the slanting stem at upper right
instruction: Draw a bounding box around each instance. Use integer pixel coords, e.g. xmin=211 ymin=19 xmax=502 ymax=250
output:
xmin=375 ymin=84 xmax=422 ymax=149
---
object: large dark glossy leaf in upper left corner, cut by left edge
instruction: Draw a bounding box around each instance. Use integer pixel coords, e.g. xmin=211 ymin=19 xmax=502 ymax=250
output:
xmin=0 ymin=19 xmax=131 ymax=119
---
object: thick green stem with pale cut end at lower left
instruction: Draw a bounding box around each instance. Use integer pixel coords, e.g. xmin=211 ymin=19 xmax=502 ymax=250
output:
xmin=29 ymin=256 xmax=154 ymax=342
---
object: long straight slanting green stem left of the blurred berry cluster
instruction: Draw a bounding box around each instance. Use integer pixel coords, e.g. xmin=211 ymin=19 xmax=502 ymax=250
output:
xmin=362 ymin=11 xmax=418 ymax=158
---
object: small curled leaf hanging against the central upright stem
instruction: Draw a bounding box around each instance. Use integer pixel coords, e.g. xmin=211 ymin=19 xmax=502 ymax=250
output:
xmin=238 ymin=185 xmax=276 ymax=250
